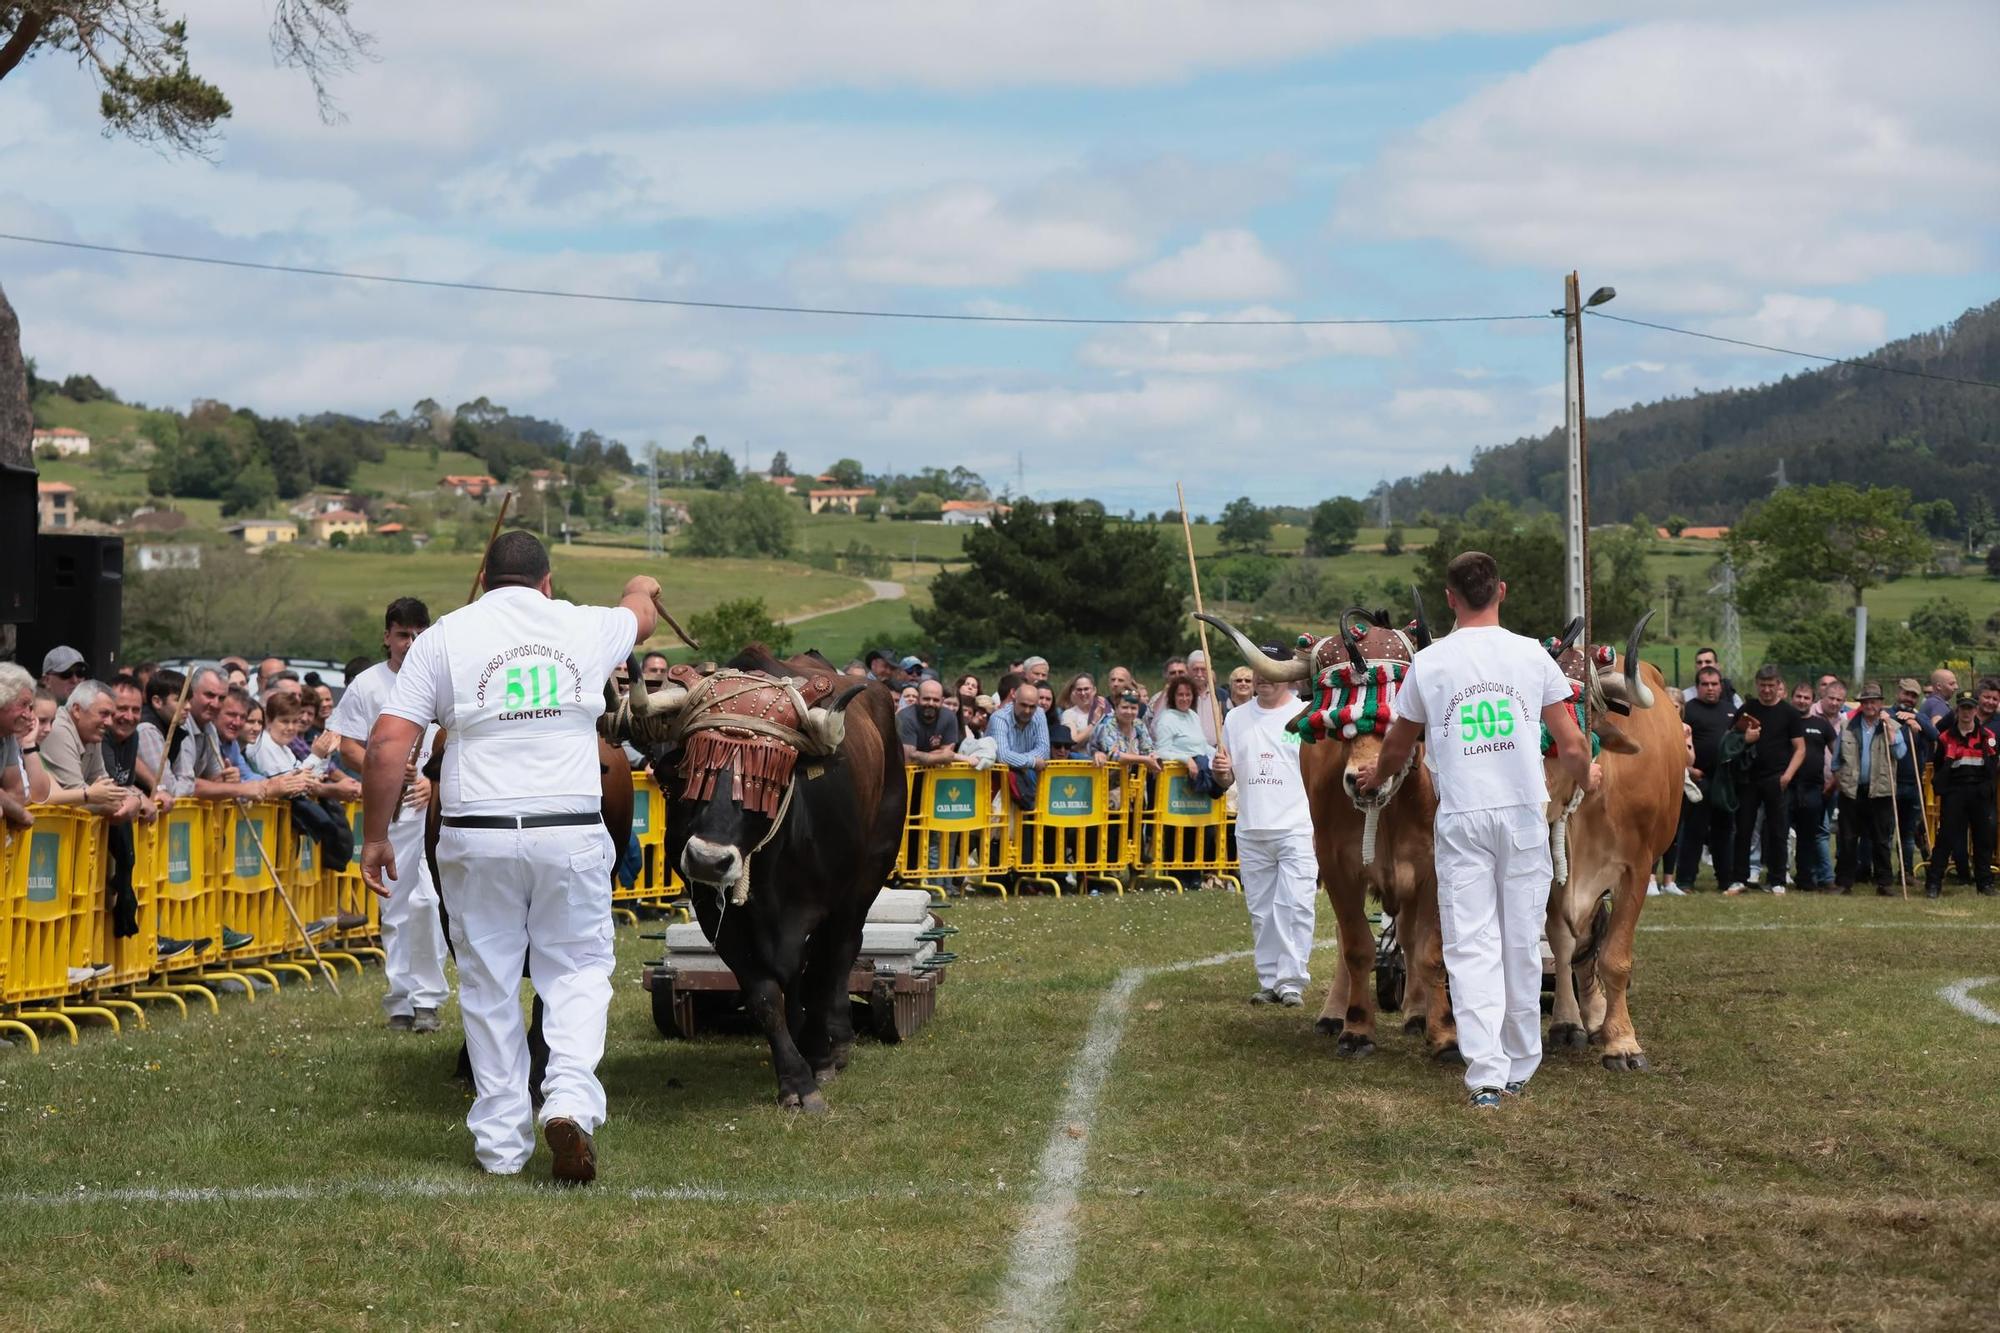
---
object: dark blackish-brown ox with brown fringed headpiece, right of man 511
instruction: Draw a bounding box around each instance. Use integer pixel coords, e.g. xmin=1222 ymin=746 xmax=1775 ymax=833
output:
xmin=620 ymin=644 xmax=904 ymax=1111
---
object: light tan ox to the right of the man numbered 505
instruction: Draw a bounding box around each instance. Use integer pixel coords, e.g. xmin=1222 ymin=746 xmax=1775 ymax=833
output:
xmin=1544 ymin=612 xmax=1688 ymax=1071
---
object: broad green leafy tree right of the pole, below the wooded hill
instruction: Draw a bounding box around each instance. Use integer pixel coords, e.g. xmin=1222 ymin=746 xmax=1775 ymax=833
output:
xmin=1730 ymin=482 xmax=1930 ymax=614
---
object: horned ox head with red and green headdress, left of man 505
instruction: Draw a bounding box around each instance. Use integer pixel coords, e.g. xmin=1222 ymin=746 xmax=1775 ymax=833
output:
xmin=1202 ymin=588 xmax=1430 ymax=811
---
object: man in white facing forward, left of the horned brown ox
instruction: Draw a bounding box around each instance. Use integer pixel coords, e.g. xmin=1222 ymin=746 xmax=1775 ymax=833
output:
xmin=1210 ymin=648 xmax=1320 ymax=1009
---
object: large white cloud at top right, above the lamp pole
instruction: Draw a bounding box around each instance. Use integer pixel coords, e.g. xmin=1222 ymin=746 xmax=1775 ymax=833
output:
xmin=1338 ymin=4 xmax=2000 ymax=290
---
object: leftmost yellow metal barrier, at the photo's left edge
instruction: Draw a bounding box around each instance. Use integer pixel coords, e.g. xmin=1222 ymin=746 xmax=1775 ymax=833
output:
xmin=0 ymin=805 xmax=118 ymax=1049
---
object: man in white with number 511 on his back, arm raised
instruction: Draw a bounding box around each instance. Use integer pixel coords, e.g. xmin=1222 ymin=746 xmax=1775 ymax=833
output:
xmin=362 ymin=532 xmax=660 ymax=1185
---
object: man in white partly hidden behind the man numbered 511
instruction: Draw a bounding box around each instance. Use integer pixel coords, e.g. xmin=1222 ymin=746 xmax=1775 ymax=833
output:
xmin=326 ymin=596 xmax=452 ymax=1033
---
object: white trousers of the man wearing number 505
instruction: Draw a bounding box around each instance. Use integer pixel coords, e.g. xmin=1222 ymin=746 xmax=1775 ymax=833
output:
xmin=1436 ymin=805 xmax=1556 ymax=1089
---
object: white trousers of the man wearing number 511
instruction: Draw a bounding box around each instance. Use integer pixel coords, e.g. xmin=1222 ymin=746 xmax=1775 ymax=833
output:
xmin=438 ymin=825 xmax=612 ymax=1175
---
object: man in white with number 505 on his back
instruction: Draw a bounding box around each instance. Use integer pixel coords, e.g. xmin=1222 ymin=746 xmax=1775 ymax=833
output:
xmin=1356 ymin=550 xmax=1600 ymax=1109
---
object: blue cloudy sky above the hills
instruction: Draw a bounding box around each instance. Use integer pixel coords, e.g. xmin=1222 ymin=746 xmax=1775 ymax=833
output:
xmin=0 ymin=0 xmax=2000 ymax=510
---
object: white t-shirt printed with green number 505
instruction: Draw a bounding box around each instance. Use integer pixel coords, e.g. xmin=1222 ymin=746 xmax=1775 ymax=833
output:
xmin=1396 ymin=624 xmax=1570 ymax=815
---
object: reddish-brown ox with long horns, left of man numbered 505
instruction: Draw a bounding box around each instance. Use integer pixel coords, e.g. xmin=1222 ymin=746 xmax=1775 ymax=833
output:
xmin=1202 ymin=604 xmax=1458 ymax=1059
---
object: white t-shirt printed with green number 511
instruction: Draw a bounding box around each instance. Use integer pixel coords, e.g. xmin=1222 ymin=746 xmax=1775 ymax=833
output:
xmin=382 ymin=588 xmax=638 ymax=815
